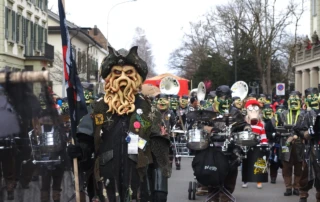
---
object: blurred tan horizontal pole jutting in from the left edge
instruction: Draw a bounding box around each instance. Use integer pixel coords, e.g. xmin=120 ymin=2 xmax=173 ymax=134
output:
xmin=0 ymin=71 xmax=49 ymax=83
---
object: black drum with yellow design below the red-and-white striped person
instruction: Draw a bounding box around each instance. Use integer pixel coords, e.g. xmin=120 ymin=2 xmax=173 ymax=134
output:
xmin=242 ymin=145 xmax=270 ymax=182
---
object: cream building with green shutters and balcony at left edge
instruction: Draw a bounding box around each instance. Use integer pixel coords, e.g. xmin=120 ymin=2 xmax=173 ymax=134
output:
xmin=0 ymin=0 xmax=54 ymax=94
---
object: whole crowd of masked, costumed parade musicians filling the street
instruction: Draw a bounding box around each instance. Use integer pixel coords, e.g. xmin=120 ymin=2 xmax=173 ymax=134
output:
xmin=0 ymin=47 xmax=320 ymax=202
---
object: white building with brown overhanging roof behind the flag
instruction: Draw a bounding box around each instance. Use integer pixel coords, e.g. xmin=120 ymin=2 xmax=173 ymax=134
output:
xmin=48 ymin=11 xmax=108 ymax=97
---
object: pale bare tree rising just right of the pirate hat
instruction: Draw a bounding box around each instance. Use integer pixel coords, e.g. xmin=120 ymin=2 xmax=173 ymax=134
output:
xmin=132 ymin=27 xmax=157 ymax=77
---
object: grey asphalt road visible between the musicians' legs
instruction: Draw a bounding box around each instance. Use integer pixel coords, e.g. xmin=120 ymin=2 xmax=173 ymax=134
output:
xmin=168 ymin=158 xmax=316 ymax=202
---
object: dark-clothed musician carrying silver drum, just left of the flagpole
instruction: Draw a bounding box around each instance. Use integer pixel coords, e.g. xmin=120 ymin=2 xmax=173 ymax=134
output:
xmin=32 ymin=92 xmax=67 ymax=202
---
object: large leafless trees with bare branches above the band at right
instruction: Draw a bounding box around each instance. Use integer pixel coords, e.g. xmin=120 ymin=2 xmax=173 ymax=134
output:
xmin=169 ymin=0 xmax=306 ymax=94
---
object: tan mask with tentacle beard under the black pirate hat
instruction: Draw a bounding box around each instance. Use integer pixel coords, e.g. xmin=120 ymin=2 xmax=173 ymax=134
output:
xmin=104 ymin=65 xmax=142 ymax=115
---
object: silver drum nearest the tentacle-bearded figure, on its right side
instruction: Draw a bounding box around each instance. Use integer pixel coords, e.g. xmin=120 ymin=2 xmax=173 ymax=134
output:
xmin=187 ymin=129 xmax=209 ymax=150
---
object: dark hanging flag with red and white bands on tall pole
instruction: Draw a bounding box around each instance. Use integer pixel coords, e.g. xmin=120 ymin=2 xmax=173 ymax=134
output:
xmin=58 ymin=0 xmax=88 ymax=135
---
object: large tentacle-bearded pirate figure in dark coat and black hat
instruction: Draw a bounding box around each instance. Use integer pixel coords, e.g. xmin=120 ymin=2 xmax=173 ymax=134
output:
xmin=69 ymin=47 xmax=171 ymax=202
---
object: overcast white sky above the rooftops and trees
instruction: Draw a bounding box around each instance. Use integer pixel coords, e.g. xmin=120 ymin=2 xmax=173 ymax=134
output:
xmin=49 ymin=0 xmax=310 ymax=74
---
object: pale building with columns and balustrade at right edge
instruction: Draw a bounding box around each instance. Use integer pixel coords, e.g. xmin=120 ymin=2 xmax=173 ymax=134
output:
xmin=293 ymin=0 xmax=320 ymax=94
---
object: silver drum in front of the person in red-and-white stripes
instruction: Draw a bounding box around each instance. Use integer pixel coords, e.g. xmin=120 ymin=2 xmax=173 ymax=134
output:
xmin=234 ymin=131 xmax=260 ymax=147
